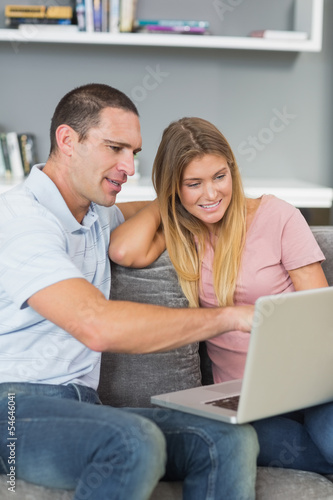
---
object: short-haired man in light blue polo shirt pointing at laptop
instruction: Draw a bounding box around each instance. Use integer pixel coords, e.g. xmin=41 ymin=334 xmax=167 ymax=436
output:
xmin=0 ymin=84 xmax=258 ymax=500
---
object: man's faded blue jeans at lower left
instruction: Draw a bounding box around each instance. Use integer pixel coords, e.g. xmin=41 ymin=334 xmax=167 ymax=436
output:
xmin=0 ymin=383 xmax=258 ymax=500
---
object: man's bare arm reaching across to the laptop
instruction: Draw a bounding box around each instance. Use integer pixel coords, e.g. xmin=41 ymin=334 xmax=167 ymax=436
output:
xmin=28 ymin=278 xmax=253 ymax=353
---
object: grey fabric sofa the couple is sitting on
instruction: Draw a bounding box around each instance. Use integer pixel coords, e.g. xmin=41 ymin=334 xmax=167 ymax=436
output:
xmin=0 ymin=226 xmax=333 ymax=500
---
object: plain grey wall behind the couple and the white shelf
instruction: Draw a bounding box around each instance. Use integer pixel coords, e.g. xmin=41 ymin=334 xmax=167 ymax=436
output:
xmin=0 ymin=0 xmax=333 ymax=186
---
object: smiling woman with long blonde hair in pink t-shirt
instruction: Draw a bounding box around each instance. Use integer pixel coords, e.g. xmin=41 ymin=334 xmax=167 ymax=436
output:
xmin=109 ymin=118 xmax=333 ymax=474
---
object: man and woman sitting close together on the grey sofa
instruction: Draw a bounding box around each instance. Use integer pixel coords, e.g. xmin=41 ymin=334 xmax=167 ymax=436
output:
xmin=0 ymin=84 xmax=333 ymax=500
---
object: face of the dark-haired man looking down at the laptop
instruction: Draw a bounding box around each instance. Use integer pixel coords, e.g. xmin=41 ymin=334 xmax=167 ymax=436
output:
xmin=69 ymin=108 xmax=142 ymax=208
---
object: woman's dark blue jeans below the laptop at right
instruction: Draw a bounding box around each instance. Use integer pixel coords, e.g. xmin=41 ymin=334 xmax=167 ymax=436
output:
xmin=253 ymin=403 xmax=333 ymax=474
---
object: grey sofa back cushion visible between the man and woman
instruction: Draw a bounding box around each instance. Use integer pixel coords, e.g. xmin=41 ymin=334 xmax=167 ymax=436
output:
xmin=98 ymin=252 xmax=201 ymax=407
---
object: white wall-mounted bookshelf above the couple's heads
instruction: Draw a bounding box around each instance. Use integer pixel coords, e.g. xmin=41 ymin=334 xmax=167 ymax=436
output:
xmin=0 ymin=0 xmax=324 ymax=52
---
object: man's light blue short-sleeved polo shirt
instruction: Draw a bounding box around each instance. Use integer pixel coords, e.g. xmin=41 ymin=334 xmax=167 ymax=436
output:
xmin=0 ymin=165 xmax=124 ymax=389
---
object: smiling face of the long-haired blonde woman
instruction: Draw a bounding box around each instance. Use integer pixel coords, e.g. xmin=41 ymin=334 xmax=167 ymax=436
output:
xmin=179 ymin=154 xmax=232 ymax=231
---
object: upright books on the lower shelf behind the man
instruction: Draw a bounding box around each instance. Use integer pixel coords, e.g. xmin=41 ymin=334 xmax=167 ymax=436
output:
xmin=0 ymin=132 xmax=38 ymax=179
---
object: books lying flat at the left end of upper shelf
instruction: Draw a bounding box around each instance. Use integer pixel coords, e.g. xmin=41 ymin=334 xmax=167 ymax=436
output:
xmin=5 ymin=5 xmax=73 ymax=28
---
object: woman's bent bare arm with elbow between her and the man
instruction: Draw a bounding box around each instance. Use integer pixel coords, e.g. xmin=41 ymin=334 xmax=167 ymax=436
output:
xmin=109 ymin=200 xmax=165 ymax=267
